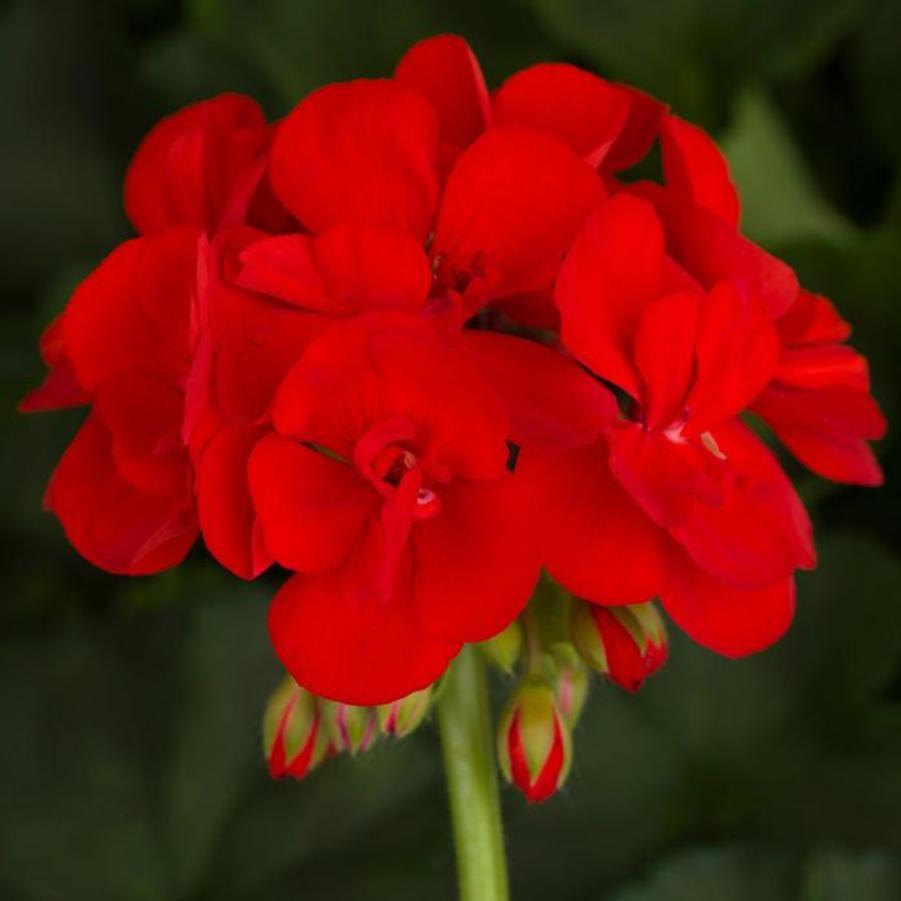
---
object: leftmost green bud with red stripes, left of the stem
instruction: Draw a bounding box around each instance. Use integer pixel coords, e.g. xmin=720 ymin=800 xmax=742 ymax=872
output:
xmin=263 ymin=676 xmax=325 ymax=779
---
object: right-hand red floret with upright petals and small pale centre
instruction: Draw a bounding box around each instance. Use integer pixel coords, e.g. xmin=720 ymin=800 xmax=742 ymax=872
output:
xmin=523 ymin=195 xmax=813 ymax=655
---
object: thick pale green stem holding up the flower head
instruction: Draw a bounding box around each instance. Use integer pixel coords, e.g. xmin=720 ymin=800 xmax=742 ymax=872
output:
xmin=438 ymin=646 xmax=509 ymax=901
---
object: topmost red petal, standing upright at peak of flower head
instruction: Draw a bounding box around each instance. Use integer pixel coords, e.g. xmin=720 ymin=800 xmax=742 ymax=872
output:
xmin=394 ymin=34 xmax=491 ymax=149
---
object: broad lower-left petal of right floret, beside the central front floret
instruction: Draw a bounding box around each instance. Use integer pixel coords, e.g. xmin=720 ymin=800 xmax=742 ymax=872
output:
xmin=517 ymin=444 xmax=663 ymax=604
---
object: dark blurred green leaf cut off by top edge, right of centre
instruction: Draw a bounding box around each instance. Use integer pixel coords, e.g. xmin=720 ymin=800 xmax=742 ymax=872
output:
xmin=527 ymin=0 xmax=864 ymax=125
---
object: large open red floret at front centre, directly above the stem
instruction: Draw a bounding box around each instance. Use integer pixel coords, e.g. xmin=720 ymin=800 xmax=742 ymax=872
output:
xmin=250 ymin=313 xmax=538 ymax=704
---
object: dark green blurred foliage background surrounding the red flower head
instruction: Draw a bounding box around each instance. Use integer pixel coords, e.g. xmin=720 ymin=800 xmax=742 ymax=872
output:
xmin=0 ymin=0 xmax=901 ymax=901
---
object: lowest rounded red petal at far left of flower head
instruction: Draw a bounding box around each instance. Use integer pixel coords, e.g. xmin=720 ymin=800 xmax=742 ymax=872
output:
xmin=45 ymin=413 xmax=197 ymax=576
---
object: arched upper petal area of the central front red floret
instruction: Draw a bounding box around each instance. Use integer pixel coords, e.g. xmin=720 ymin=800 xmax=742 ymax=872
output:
xmin=274 ymin=313 xmax=509 ymax=478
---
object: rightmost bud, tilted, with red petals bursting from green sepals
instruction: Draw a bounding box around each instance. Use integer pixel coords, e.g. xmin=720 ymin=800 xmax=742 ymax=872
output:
xmin=571 ymin=602 xmax=668 ymax=692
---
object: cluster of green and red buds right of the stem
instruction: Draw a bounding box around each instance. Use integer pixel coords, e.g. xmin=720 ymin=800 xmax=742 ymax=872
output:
xmin=483 ymin=591 xmax=667 ymax=802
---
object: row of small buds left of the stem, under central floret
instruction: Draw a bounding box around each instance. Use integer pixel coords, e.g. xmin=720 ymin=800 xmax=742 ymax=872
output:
xmin=263 ymin=676 xmax=432 ymax=779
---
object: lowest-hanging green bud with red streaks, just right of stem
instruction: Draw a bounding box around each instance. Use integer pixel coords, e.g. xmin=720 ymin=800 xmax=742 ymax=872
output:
xmin=498 ymin=679 xmax=572 ymax=803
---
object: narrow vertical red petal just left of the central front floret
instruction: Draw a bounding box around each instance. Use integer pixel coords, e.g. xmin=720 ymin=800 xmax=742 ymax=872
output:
xmin=197 ymin=426 xmax=273 ymax=579
